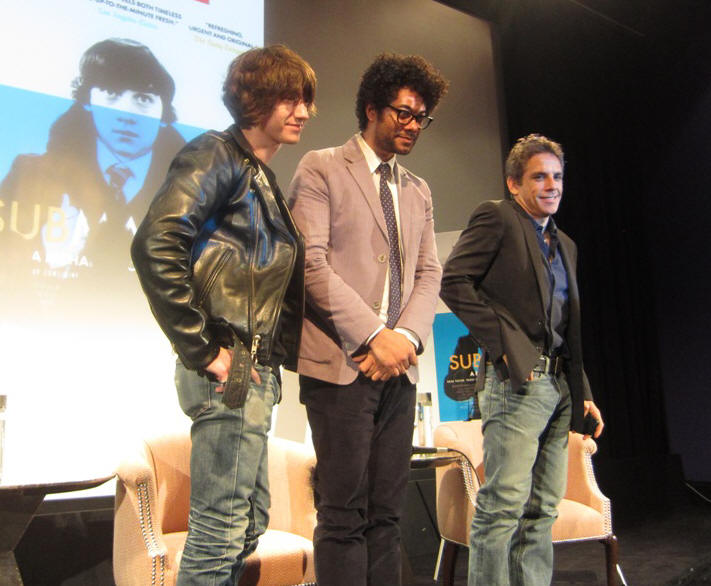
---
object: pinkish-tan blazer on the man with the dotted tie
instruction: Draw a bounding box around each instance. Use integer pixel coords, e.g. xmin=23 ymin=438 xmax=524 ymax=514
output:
xmin=287 ymin=136 xmax=442 ymax=384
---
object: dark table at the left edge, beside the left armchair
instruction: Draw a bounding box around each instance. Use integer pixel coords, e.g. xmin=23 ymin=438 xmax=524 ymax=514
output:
xmin=0 ymin=474 xmax=114 ymax=586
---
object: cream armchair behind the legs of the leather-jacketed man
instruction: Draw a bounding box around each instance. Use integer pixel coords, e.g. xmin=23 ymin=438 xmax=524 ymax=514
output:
xmin=113 ymin=433 xmax=316 ymax=586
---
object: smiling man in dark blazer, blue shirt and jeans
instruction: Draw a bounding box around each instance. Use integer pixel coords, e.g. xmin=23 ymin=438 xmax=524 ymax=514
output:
xmin=440 ymin=135 xmax=603 ymax=586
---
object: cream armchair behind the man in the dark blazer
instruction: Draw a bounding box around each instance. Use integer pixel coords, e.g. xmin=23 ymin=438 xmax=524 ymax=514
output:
xmin=434 ymin=420 xmax=619 ymax=586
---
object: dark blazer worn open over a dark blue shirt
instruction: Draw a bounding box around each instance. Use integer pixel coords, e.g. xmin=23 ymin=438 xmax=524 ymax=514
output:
xmin=440 ymin=200 xmax=592 ymax=430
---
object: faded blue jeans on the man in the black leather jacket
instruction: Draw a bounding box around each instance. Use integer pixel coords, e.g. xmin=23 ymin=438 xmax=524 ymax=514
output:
xmin=175 ymin=363 xmax=280 ymax=586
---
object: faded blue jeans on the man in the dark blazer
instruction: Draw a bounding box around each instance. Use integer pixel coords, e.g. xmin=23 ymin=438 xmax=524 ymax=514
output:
xmin=468 ymin=369 xmax=571 ymax=586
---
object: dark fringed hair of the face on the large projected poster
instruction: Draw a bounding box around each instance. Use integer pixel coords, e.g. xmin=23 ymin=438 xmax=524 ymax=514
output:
xmin=72 ymin=39 xmax=176 ymax=124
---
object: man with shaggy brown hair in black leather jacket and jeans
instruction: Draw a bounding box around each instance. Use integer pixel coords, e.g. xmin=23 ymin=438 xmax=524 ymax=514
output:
xmin=131 ymin=45 xmax=316 ymax=586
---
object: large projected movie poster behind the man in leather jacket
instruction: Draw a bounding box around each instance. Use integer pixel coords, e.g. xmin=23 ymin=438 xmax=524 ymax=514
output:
xmin=0 ymin=0 xmax=264 ymax=482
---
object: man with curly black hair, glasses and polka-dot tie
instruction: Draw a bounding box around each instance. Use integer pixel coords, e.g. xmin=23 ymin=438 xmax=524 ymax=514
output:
xmin=288 ymin=54 xmax=448 ymax=586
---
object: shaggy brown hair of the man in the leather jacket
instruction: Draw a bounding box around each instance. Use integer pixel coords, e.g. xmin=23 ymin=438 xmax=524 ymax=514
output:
xmin=222 ymin=45 xmax=316 ymax=128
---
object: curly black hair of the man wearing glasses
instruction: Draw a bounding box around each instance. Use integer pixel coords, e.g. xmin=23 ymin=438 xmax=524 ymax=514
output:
xmin=356 ymin=53 xmax=449 ymax=130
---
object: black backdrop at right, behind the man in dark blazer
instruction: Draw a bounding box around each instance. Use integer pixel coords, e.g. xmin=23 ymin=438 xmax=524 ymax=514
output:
xmin=446 ymin=0 xmax=711 ymax=481
